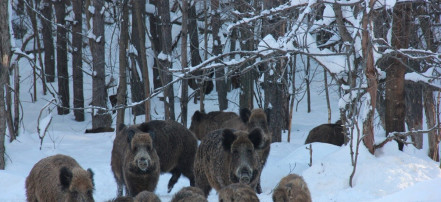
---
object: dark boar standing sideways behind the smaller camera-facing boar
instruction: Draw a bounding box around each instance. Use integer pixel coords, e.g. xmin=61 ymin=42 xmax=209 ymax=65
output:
xmin=136 ymin=120 xmax=198 ymax=193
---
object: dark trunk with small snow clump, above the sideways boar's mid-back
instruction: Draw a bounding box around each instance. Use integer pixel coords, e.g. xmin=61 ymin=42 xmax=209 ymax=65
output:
xmin=158 ymin=0 xmax=175 ymax=120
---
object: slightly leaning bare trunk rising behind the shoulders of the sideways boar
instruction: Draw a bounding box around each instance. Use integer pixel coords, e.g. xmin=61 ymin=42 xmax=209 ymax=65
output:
xmin=134 ymin=0 xmax=151 ymax=122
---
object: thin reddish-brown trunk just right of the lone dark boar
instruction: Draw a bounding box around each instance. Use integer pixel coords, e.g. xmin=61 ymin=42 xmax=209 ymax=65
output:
xmin=361 ymin=0 xmax=374 ymax=154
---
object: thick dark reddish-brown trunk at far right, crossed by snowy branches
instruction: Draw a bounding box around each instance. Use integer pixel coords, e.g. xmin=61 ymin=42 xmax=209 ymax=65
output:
xmin=386 ymin=3 xmax=412 ymax=151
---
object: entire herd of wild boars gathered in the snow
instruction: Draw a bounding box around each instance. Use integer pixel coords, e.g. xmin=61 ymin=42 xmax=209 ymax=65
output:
xmin=25 ymin=108 xmax=345 ymax=202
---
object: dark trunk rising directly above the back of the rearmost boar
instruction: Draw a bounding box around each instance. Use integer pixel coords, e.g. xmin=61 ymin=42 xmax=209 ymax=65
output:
xmin=211 ymin=0 xmax=228 ymax=111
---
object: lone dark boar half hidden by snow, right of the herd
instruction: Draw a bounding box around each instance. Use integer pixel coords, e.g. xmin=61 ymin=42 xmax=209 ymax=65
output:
xmin=305 ymin=120 xmax=345 ymax=146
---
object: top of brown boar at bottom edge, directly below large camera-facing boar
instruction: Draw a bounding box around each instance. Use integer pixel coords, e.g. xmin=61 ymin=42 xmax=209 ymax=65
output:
xmin=219 ymin=183 xmax=259 ymax=202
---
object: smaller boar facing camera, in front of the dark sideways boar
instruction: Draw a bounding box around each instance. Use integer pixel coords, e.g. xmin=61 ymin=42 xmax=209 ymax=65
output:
xmin=111 ymin=125 xmax=160 ymax=196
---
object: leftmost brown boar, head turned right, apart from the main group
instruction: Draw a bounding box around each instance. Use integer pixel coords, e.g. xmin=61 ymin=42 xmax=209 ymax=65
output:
xmin=26 ymin=154 xmax=94 ymax=202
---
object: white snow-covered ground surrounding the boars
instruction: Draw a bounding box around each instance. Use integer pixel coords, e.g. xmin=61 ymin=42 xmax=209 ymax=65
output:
xmin=0 ymin=68 xmax=441 ymax=202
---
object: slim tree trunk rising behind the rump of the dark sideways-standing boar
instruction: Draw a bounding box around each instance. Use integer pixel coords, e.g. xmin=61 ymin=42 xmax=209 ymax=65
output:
xmin=181 ymin=0 xmax=188 ymax=126
